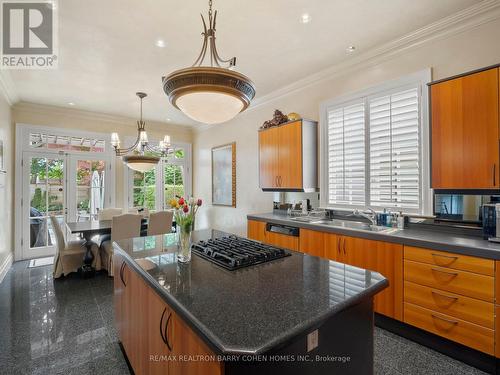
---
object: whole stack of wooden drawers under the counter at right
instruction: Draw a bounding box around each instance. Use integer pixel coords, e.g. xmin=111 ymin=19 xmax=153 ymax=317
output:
xmin=404 ymin=246 xmax=495 ymax=354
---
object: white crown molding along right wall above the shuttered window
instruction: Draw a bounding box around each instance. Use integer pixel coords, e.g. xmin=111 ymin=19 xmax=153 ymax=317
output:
xmin=193 ymin=0 xmax=500 ymax=132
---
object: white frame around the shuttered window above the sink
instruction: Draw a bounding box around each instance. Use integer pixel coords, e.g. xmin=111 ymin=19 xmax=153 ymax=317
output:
xmin=319 ymin=68 xmax=433 ymax=215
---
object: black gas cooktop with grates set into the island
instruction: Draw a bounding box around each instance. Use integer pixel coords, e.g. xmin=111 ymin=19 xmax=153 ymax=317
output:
xmin=192 ymin=235 xmax=292 ymax=271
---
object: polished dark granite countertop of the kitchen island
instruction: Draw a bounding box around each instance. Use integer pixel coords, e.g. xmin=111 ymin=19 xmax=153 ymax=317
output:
xmin=113 ymin=230 xmax=388 ymax=354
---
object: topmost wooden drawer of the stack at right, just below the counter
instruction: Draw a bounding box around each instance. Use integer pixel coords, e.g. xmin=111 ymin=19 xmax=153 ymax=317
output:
xmin=404 ymin=246 xmax=495 ymax=276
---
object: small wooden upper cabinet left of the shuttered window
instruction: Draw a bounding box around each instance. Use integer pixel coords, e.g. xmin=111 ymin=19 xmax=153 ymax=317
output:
xmin=259 ymin=120 xmax=318 ymax=191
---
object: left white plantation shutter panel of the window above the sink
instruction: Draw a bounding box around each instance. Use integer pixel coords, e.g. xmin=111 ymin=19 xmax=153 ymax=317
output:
xmin=328 ymin=102 xmax=366 ymax=206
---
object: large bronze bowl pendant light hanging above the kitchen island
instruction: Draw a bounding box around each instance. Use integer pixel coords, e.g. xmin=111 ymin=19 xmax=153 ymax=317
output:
xmin=162 ymin=0 xmax=255 ymax=124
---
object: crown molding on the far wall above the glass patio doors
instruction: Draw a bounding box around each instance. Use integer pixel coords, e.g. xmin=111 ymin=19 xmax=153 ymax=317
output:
xmin=12 ymin=102 xmax=192 ymax=132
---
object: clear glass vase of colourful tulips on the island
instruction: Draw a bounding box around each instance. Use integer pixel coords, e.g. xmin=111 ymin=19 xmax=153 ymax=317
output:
xmin=169 ymin=197 xmax=202 ymax=263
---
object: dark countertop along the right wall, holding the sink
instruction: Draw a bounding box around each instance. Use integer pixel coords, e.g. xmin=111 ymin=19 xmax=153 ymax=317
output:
xmin=247 ymin=213 xmax=500 ymax=260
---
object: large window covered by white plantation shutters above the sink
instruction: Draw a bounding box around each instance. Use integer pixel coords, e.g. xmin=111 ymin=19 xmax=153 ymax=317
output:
xmin=321 ymin=72 xmax=431 ymax=214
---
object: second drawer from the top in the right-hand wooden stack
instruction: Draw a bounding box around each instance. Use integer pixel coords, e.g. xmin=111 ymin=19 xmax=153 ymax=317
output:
xmin=404 ymin=260 xmax=495 ymax=302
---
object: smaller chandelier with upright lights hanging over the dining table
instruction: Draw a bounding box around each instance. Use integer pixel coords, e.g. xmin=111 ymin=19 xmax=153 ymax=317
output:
xmin=111 ymin=92 xmax=172 ymax=172
